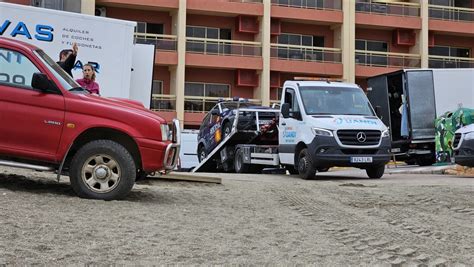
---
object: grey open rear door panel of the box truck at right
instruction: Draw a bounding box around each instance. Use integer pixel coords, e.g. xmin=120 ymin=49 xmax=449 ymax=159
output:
xmin=405 ymin=70 xmax=436 ymax=140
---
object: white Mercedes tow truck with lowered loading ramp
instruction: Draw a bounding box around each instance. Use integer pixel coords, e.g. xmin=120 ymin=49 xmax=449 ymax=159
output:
xmin=193 ymin=80 xmax=390 ymax=179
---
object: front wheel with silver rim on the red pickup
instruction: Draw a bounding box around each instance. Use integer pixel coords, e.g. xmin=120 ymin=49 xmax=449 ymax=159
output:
xmin=69 ymin=140 xmax=137 ymax=200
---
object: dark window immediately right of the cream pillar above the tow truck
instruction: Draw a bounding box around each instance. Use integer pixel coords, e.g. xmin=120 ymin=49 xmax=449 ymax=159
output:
xmin=355 ymin=39 xmax=388 ymax=66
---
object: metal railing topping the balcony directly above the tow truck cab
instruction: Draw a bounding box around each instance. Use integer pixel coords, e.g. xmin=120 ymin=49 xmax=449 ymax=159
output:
xmin=270 ymin=44 xmax=342 ymax=63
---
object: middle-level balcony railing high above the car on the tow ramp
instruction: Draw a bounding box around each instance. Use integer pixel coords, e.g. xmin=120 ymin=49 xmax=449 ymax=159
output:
xmin=186 ymin=37 xmax=262 ymax=57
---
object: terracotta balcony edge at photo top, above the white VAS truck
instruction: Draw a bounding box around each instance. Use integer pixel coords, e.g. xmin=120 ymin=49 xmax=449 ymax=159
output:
xmin=95 ymin=0 xmax=179 ymax=10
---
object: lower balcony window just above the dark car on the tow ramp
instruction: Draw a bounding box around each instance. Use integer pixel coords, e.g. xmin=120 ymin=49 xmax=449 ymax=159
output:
xmin=184 ymin=82 xmax=230 ymax=112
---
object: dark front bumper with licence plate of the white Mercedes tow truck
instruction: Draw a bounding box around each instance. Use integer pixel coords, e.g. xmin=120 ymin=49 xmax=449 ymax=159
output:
xmin=308 ymin=136 xmax=390 ymax=169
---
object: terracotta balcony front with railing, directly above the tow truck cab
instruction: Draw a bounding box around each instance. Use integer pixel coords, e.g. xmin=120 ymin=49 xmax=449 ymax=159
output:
xmin=270 ymin=44 xmax=342 ymax=76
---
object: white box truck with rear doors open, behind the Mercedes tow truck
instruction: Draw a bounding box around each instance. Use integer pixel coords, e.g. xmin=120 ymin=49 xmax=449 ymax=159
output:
xmin=367 ymin=69 xmax=474 ymax=166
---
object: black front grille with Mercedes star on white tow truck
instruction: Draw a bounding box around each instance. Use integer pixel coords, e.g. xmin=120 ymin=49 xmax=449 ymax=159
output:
xmin=337 ymin=130 xmax=381 ymax=146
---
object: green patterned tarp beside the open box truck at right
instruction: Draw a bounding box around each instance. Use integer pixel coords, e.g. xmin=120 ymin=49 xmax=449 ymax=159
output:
xmin=435 ymin=108 xmax=474 ymax=162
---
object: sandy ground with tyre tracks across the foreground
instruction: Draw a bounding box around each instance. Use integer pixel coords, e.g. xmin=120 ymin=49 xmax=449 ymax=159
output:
xmin=0 ymin=167 xmax=474 ymax=266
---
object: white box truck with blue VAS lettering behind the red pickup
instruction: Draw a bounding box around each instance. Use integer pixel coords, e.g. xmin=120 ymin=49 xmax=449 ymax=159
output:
xmin=0 ymin=3 xmax=155 ymax=107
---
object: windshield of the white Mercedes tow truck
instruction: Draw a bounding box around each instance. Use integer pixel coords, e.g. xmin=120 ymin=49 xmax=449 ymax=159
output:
xmin=300 ymin=86 xmax=375 ymax=116
